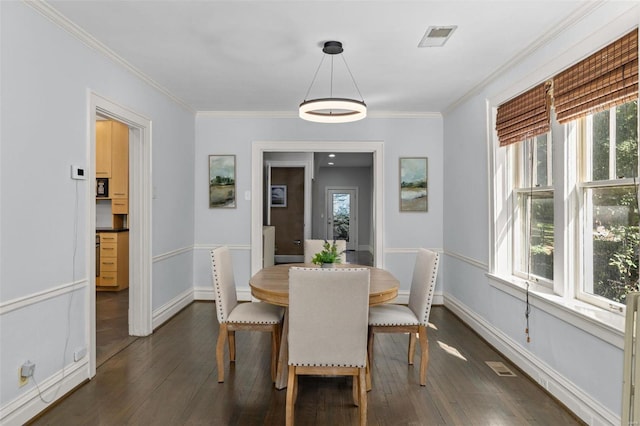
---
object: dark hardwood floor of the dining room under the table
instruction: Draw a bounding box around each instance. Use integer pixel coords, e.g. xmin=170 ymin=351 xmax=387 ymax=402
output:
xmin=32 ymin=302 xmax=583 ymax=426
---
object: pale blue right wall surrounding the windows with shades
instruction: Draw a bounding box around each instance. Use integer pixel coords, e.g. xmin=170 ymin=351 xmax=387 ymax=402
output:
xmin=443 ymin=2 xmax=638 ymax=424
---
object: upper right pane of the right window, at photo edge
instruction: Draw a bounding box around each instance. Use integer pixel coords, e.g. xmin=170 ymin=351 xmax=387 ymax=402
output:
xmin=616 ymin=101 xmax=638 ymax=177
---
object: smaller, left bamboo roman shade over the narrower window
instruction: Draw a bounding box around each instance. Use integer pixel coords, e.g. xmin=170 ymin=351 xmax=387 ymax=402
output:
xmin=496 ymin=83 xmax=551 ymax=146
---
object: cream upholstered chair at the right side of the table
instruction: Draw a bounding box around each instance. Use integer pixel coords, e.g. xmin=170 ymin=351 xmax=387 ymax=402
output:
xmin=368 ymin=249 xmax=440 ymax=386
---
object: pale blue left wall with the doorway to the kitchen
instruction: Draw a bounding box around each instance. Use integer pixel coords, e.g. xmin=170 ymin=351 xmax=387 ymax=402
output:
xmin=0 ymin=1 xmax=195 ymax=424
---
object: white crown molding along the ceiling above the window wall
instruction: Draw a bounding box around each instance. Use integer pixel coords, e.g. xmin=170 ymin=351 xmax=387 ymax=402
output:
xmin=443 ymin=0 xmax=607 ymax=114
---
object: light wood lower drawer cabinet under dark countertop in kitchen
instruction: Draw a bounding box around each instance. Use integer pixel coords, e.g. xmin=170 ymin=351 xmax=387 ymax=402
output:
xmin=96 ymin=232 xmax=129 ymax=291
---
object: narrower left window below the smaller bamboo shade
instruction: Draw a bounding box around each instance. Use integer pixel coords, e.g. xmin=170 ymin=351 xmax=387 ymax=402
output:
xmin=512 ymin=133 xmax=554 ymax=286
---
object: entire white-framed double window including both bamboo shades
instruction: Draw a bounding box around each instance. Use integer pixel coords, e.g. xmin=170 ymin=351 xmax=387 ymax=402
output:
xmin=496 ymin=29 xmax=640 ymax=324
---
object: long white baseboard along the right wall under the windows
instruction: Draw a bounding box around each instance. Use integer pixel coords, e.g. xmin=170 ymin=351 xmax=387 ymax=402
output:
xmin=444 ymin=294 xmax=620 ymax=426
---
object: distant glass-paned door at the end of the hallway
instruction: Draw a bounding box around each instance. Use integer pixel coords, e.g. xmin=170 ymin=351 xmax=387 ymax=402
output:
xmin=327 ymin=188 xmax=358 ymax=250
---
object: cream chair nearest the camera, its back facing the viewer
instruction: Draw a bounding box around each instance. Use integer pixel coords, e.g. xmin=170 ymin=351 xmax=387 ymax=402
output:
xmin=286 ymin=267 xmax=369 ymax=425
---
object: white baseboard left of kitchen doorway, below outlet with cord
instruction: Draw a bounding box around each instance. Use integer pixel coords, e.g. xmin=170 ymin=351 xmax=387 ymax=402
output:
xmin=0 ymin=357 xmax=89 ymax=426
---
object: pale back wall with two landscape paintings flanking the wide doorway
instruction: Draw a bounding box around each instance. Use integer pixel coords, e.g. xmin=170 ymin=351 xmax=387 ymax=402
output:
xmin=194 ymin=113 xmax=443 ymax=298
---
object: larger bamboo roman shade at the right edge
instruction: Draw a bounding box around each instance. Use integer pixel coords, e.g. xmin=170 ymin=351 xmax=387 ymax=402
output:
xmin=552 ymin=29 xmax=638 ymax=123
